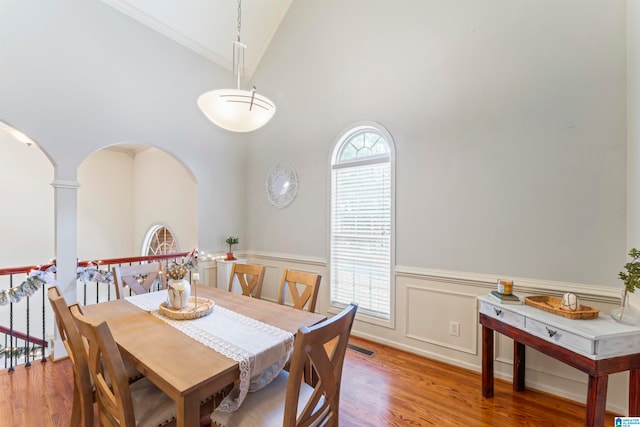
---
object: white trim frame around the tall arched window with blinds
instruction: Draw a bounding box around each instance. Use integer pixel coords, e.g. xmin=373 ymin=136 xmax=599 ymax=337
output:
xmin=327 ymin=121 xmax=396 ymax=329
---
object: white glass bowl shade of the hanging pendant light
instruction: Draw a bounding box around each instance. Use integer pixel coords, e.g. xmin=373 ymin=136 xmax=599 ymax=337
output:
xmin=198 ymin=89 xmax=276 ymax=132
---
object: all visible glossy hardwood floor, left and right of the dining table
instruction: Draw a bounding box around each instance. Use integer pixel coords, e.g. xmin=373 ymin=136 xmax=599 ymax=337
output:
xmin=0 ymin=338 xmax=614 ymax=427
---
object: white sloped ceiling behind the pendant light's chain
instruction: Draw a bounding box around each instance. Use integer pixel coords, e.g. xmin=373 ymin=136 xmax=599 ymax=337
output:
xmin=102 ymin=0 xmax=293 ymax=79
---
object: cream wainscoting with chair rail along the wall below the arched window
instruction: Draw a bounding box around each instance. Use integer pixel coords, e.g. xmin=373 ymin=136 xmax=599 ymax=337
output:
xmin=238 ymin=252 xmax=628 ymax=414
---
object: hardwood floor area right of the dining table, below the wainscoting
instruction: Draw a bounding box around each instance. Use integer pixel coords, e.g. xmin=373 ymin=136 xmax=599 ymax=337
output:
xmin=340 ymin=338 xmax=614 ymax=427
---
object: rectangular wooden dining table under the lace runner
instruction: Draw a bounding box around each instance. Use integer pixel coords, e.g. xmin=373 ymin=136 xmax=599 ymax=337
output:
xmin=83 ymin=285 xmax=326 ymax=427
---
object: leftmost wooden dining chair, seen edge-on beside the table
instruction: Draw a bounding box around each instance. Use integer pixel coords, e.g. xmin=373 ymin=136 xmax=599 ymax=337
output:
xmin=47 ymin=286 xmax=94 ymax=427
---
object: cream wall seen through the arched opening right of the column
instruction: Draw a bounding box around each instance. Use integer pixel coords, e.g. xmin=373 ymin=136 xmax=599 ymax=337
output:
xmin=78 ymin=143 xmax=198 ymax=260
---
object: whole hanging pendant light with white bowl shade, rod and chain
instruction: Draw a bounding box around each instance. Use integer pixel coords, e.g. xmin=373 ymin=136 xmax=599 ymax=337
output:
xmin=198 ymin=0 xmax=276 ymax=132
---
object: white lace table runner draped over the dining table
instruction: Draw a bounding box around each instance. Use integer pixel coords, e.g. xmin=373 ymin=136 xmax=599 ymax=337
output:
xmin=126 ymin=290 xmax=293 ymax=412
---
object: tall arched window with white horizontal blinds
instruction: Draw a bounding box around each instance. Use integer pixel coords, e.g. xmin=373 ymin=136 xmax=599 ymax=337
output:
xmin=330 ymin=124 xmax=394 ymax=319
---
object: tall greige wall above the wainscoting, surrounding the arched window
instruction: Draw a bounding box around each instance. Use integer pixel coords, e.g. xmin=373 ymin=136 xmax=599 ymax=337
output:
xmin=247 ymin=0 xmax=627 ymax=287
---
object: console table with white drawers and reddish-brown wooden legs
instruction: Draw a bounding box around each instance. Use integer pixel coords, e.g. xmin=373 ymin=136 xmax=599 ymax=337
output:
xmin=478 ymin=296 xmax=640 ymax=426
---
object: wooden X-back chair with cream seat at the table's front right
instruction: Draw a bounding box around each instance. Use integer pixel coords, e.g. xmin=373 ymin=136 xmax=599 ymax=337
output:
xmin=211 ymin=304 xmax=358 ymax=427
